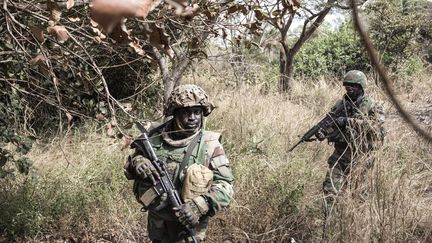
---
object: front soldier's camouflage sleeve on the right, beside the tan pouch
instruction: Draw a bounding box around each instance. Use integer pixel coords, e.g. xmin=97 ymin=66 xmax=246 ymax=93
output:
xmin=204 ymin=133 xmax=234 ymax=215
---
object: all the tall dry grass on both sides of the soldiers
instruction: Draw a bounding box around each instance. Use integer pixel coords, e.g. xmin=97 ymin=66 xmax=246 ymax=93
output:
xmin=0 ymin=59 xmax=432 ymax=242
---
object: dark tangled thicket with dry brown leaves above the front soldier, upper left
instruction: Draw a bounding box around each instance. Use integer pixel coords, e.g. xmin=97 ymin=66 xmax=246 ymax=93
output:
xmin=0 ymin=0 xmax=250 ymax=137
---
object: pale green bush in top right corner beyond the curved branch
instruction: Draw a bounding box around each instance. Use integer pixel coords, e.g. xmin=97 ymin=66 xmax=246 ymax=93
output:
xmin=366 ymin=0 xmax=432 ymax=74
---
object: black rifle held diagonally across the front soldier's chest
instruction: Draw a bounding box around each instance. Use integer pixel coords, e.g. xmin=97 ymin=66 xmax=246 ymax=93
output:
xmin=131 ymin=122 xmax=199 ymax=243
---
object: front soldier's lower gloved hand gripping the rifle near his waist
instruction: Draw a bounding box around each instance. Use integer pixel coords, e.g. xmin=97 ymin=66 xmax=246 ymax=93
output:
xmin=174 ymin=196 xmax=209 ymax=228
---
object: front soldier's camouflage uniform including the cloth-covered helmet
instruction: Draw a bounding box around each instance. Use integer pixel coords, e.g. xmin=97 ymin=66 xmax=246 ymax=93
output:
xmin=125 ymin=85 xmax=234 ymax=242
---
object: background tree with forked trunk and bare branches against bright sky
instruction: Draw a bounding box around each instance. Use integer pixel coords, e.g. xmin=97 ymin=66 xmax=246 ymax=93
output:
xmin=240 ymin=0 xmax=338 ymax=92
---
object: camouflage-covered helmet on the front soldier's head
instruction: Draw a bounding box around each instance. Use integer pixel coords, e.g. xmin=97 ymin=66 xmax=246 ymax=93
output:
xmin=164 ymin=84 xmax=214 ymax=116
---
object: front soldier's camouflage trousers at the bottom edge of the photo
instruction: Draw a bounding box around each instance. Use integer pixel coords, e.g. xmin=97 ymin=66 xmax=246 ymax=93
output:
xmin=147 ymin=211 xmax=209 ymax=243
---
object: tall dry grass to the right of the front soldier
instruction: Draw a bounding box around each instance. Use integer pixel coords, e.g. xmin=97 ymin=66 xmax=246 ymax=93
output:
xmin=181 ymin=65 xmax=432 ymax=242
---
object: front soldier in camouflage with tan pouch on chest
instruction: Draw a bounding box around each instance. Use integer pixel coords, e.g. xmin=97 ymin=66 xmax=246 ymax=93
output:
xmin=125 ymin=85 xmax=234 ymax=242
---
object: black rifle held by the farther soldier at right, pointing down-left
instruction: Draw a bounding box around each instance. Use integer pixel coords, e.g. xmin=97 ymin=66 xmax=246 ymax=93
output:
xmin=288 ymin=96 xmax=363 ymax=153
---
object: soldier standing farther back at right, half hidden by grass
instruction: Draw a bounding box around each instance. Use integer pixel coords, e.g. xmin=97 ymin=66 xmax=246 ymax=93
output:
xmin=316 ymin=70 xmax=384 ymax=216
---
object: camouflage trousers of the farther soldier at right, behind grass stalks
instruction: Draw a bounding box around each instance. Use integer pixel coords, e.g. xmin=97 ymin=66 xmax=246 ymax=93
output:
xmin=323 ymin=146 xmax=373 ymax=218
